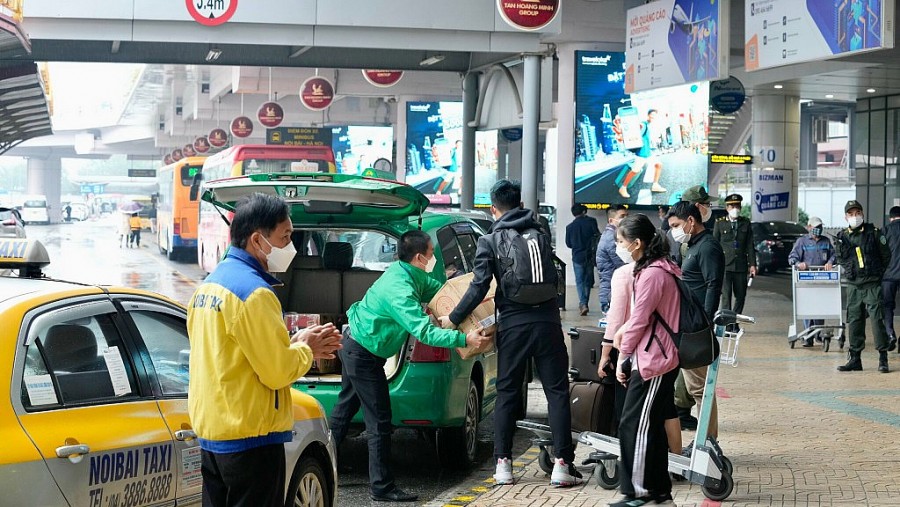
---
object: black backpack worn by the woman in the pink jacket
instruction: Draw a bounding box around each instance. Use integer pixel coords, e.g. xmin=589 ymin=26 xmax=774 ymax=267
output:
xmin=653 ymin=274 xmax=719 ymax=370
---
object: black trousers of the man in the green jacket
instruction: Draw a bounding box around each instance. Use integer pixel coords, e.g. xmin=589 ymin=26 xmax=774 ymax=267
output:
xmin=330 ymin=329 xmax=396 ymax=495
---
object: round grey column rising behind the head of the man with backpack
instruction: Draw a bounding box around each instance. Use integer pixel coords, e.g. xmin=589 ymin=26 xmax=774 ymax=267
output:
xmin=522 ymin=55 xmax=541 ymax=210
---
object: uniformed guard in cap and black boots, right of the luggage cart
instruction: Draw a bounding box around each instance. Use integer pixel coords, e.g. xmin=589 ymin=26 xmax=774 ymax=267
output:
xmin=834 ymin=200 xmax=897 ymax=373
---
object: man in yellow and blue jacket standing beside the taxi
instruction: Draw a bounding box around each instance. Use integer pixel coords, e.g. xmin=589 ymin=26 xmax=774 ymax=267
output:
xmin=188 ymin=194 xmax=341 ymax=507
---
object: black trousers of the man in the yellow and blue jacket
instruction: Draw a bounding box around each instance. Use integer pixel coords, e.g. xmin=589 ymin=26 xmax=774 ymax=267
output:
xmin=200 ymin=444 xmax=285 ymax=507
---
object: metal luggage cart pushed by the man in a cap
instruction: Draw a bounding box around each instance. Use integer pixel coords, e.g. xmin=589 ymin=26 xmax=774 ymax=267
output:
xmin=788 ymin=266 xmax=846 ymax=352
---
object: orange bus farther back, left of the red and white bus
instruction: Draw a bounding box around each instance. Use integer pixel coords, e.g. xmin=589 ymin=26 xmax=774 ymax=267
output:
xmin=156 ymin=157 xmax=206 ymax=259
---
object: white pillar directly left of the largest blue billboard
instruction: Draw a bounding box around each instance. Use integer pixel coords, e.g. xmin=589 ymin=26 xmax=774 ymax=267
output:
xmin=547 ymin=46 xmax=576 ymax=288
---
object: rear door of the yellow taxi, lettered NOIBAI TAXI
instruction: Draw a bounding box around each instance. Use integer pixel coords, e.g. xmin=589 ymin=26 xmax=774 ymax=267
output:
xmin=12 ymin=299 xmax=176 ymax=507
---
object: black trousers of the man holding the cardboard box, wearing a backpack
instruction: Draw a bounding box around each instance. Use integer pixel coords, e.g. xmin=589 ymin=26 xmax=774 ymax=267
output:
xmin=494 ymin=322 xmax=575 ymax=463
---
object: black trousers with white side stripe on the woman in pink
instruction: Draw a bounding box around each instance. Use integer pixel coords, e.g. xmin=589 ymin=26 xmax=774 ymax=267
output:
xmin=619 ymin=368 xmax=679 ymax=498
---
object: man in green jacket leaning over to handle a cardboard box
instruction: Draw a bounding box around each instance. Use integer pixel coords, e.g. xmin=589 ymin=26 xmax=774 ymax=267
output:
xmin=330 ymin=230 xmax=490 ymax=502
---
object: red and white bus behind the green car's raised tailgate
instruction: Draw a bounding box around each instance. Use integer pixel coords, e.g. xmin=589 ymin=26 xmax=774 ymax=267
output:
xmin=197 ymin=144 xmax=336 ymax=273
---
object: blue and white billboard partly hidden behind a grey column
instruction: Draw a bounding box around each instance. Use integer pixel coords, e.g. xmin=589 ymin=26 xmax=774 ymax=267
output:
xmin=406 ymin=102 xmax=498 ymax=205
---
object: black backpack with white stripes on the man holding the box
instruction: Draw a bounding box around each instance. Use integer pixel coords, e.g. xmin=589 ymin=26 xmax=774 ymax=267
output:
xmin=493 ymin=229 xmax=556 ymax=305
